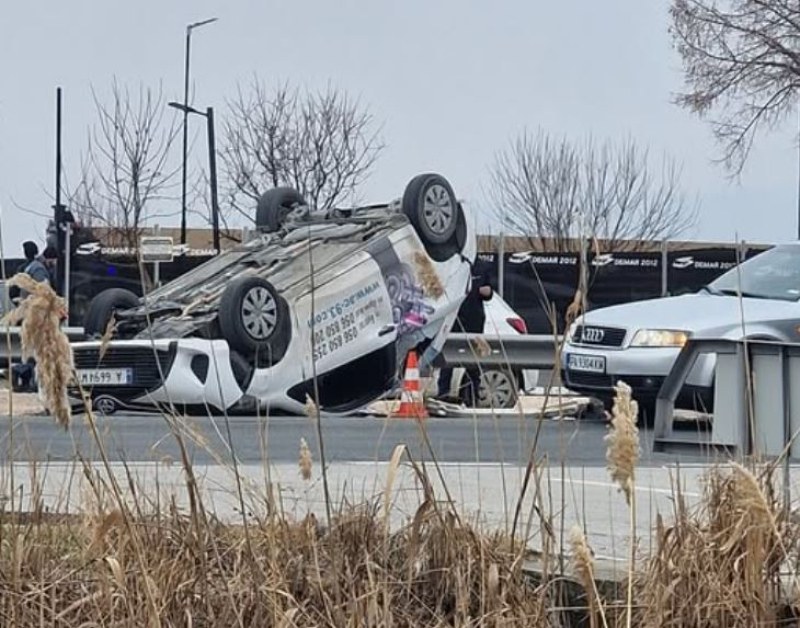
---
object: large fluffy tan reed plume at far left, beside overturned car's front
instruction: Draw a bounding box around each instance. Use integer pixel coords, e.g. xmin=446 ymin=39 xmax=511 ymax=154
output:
xmin=4 ymin=273 xmax=73 ymax=427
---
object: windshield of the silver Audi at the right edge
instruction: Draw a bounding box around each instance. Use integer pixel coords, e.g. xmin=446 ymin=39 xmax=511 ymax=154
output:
xmin=706 ymin=244 xmax=800 ymax=301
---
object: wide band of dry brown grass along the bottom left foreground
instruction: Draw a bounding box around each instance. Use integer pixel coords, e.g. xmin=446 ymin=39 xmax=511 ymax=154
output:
xmin=0 ymin=478 xmax=550 ymax=627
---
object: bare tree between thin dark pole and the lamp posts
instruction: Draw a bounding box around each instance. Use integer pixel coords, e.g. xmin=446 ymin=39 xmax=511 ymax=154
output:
xmin=68 ymin=81 xmax=180 ymax=247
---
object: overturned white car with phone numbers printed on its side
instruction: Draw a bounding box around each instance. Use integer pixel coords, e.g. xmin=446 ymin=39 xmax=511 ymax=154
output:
xmin=71 ymin=174 xmax=476 ymax=413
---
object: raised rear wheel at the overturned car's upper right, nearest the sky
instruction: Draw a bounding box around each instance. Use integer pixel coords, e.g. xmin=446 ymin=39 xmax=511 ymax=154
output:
xmin=402 ymin=173 xmax=463 ymax=248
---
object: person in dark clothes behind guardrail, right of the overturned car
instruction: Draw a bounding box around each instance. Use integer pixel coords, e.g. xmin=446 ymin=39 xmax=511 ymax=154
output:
xmin=438 ymin=259 xmax=494 ymax=406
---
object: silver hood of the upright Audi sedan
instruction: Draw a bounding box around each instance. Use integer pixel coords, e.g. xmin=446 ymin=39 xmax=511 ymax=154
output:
xmin=578 ymin=293 xmax=800 ymax=336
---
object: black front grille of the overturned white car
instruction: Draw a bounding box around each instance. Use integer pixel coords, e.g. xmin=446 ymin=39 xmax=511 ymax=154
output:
xmin=73 ymin=344 xmax=175 ymax=394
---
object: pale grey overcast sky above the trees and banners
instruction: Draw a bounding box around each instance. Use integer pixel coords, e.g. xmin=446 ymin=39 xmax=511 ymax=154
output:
xmin=0 ymin=0 xmax=798 ymax=256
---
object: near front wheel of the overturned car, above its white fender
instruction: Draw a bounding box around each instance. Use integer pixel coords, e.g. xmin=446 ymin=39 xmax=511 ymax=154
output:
xmin=218 ymin=277 xmax=292 ymax=367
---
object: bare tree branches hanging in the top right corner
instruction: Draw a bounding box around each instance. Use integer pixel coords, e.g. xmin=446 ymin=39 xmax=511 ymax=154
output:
xmin=670 ymin=0 xmax=800 ymax=174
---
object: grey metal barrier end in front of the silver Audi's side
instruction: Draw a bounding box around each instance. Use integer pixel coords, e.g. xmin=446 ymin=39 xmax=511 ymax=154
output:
xmin=653 ymin=339 xmax=800 ymax=461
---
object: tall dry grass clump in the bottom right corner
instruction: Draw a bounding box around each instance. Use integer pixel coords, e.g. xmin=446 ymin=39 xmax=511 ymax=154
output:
xmin=634 ymin=464 xmax=800 ymax=628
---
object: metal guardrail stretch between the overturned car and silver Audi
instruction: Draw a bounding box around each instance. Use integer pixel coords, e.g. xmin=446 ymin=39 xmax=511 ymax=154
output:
xmin=433 ymin=334 xmax=561 ymax=369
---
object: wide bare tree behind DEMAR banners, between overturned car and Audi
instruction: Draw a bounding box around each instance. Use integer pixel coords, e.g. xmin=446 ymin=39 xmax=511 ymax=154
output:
xmin=489 ymin=131 xmax=695 ymax=251
